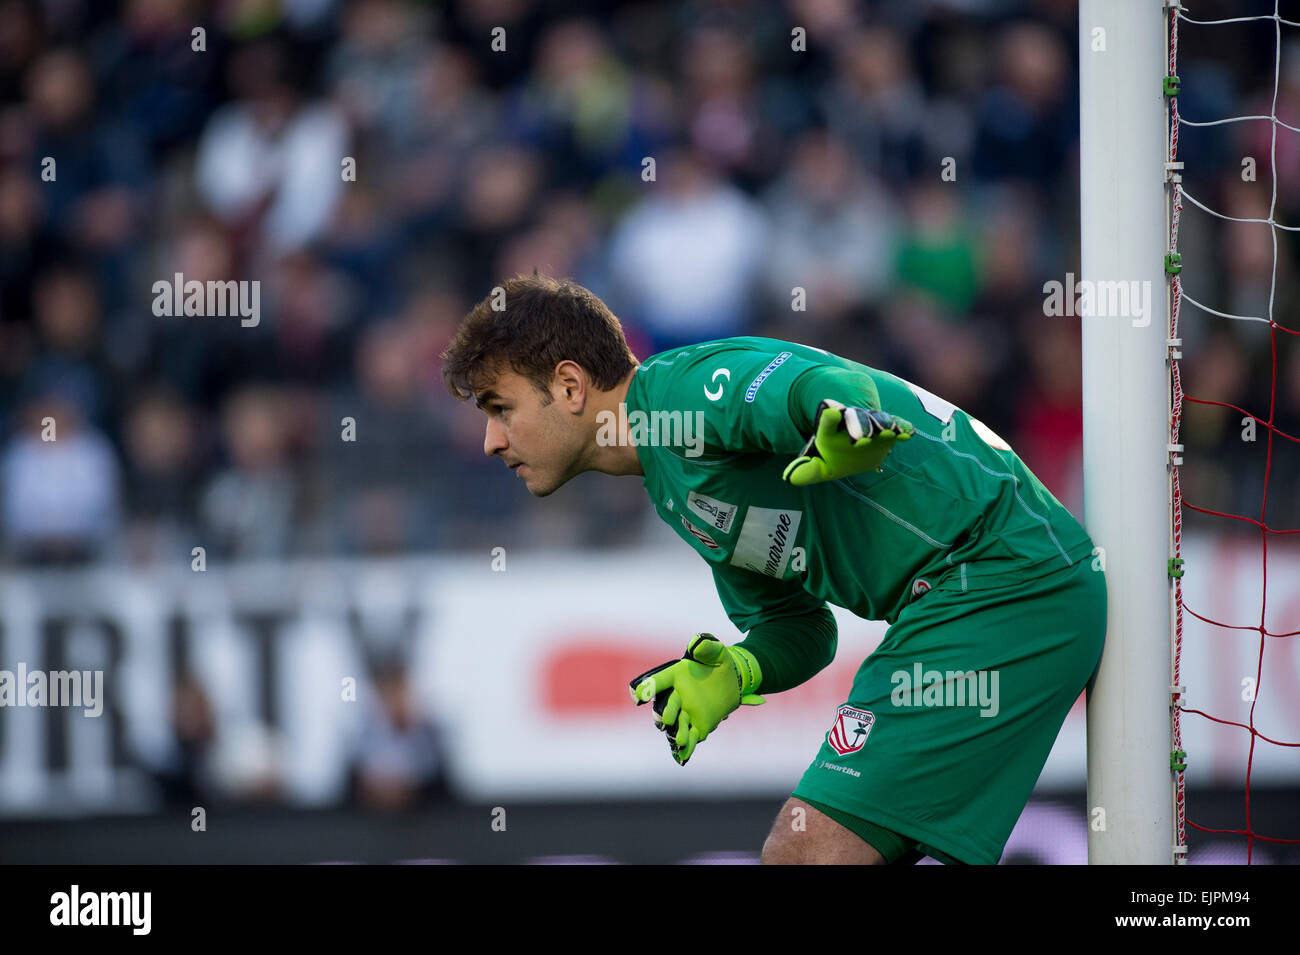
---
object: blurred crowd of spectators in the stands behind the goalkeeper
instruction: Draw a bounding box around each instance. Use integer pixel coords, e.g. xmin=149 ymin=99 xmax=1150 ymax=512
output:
xmin=0 ymin=0 xmax=1300 ymax=565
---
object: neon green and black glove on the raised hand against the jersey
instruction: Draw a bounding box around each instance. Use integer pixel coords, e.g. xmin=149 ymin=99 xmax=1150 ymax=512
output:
xmin=781 ymin=398 xmax=917 ymax=487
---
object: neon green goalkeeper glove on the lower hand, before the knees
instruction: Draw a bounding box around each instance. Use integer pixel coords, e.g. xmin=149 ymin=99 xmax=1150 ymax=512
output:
xmin=629 ymin=633 xmax=764 ymax=765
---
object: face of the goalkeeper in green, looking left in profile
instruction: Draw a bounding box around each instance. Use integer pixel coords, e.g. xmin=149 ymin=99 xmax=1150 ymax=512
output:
xmin=475 ymin=370 xmax=586 ymax=498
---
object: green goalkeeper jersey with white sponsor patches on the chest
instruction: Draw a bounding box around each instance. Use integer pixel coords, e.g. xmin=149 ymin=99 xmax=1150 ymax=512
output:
xmin=624 ymin=338 xmax=1093 ymax=631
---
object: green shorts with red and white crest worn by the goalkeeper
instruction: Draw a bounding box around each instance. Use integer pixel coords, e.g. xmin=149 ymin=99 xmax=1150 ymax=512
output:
xmin=793 ymin=559 xmax=1106 ymax=864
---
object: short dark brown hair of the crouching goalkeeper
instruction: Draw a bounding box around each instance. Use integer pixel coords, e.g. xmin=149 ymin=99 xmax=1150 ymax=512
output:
xmin=442 ymin=270 xmax=637 ymax=403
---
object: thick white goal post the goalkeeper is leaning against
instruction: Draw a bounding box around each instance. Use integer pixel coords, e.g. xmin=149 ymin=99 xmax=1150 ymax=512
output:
xmin=1076 ymin=0 xmax=1175 ymax=865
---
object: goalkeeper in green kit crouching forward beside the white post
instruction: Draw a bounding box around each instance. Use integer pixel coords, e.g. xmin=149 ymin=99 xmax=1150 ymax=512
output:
xmin=443 ymin=274 xmax=1106 ymax=864
